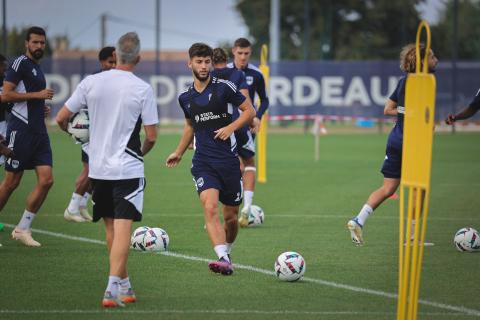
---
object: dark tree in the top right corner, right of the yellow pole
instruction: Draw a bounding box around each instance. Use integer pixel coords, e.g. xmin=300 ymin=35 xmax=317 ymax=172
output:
xmin=432 ymin=0 xmax=480 ymax=60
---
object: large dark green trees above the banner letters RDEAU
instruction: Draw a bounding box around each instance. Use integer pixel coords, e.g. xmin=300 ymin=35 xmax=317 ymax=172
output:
xmin=236 ymin=0 xmax=425 ymax=60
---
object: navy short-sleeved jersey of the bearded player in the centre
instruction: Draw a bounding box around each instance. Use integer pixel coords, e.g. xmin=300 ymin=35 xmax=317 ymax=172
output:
xmin=178 ymin=76 xmax=246 ymax=162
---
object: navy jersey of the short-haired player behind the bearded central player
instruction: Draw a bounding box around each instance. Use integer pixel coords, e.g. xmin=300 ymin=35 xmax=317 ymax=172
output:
xmin=227 ymin=63 xmax=269 ymax=119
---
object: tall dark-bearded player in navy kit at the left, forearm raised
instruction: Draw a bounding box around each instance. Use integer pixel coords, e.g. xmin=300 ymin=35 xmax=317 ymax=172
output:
xmin=0 ymin=27 xmax=54 ymax=247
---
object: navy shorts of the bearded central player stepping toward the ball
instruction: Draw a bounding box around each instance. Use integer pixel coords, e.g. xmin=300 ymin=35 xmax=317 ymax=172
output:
xmin=191 ymin=159 xmax=243 ymax=206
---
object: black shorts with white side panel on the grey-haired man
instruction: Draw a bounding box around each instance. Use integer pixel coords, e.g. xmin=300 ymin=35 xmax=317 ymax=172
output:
xmin=92 ymin=178 xmax=145 ymax=222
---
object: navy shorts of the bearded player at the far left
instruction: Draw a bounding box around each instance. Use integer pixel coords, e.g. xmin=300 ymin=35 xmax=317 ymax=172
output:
xmin=5 ymin=130 xmax=53 ymax=172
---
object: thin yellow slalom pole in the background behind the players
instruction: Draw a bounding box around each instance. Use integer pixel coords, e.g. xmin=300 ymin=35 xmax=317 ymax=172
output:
xmin=252 ymin=44 xmax=270 ymax=183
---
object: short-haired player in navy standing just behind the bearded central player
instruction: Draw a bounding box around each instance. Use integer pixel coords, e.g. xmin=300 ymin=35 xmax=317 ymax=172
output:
xmin=228 ymin=38 xmax=269 ymax=227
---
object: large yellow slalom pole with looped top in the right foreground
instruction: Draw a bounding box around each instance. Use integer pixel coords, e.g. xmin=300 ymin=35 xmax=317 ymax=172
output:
xmin=397 ymin=21 xmax=436 ymax=320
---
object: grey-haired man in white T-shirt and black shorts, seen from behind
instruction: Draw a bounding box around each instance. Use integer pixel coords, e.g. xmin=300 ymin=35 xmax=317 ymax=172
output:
xmin=57 ymin=32 xmax=158 ymax=308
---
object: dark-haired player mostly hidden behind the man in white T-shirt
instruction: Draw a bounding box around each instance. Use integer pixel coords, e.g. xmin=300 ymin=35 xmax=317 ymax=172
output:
xmin=63 ymin=47 xmax=116 ymax=222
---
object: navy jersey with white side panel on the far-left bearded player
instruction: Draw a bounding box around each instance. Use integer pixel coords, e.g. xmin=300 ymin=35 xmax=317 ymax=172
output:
xmin=5 ymin=55 xmax=47 ymax=133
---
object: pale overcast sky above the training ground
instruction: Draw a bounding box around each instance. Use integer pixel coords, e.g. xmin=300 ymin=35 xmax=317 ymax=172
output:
xmin=6 ymin=0 xmax=443 ymax=50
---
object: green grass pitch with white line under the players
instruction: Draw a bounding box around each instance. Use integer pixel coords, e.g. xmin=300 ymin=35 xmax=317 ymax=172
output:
xmin=0 ymin=130 xmax=480 ymax=320
